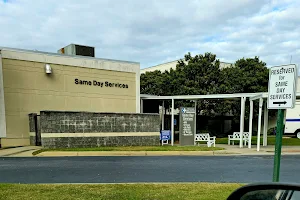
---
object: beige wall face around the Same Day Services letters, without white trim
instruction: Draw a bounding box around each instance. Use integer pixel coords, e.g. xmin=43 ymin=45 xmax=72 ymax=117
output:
xmin=2 ymin=59 xmax=136 ymax=146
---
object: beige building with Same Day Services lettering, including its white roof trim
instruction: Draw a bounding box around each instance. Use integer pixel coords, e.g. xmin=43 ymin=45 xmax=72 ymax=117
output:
xmin=0 ymin=47 xmax=140 ymax=147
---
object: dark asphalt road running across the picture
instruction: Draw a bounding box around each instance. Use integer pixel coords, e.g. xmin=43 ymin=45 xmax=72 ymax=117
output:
xmin=0 ymin=156 xmax=300 ymax=183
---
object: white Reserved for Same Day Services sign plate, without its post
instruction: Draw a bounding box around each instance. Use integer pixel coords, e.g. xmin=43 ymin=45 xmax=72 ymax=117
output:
xmin=268 ymin=64 xmax=298 ymax=109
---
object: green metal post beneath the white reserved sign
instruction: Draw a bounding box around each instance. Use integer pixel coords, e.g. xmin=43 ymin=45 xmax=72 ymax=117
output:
xmin=273 ymin=109 xmax=284 ymax=182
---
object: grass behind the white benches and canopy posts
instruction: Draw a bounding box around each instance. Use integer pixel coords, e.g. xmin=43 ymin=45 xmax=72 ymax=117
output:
xmin=216 ymin=135 xmax=300 ymax=146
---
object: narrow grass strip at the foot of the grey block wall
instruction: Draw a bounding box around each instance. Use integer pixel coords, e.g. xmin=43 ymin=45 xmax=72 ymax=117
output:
xmin=33 ymin=145 xmax=224 ymax=155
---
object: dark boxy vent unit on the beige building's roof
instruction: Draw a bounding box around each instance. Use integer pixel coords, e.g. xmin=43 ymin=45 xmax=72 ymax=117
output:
xmin=57 ymin=44 xmax=95 ymax=57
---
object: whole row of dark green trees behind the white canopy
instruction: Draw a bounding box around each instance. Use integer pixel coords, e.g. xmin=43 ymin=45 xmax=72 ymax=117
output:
xmin=140 ymin=53 xmax=269 ymax=120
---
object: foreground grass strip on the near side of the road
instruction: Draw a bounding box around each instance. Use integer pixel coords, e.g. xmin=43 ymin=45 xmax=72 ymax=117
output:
xmin=0 ymin=183 xmax=242 ymax=200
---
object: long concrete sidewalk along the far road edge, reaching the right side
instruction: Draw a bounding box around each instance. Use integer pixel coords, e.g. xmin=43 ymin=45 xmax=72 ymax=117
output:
xmin=36 ymin=144 xmax=300 ymax=157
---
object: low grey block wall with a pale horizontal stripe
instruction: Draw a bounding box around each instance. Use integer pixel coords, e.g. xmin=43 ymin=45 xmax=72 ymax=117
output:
xmin=40 ymin=111 xmax=160 ymax=148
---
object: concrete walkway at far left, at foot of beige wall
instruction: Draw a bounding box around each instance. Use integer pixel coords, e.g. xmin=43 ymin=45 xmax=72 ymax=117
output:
xmin=0 ymin=146 xmax=42 ymax=157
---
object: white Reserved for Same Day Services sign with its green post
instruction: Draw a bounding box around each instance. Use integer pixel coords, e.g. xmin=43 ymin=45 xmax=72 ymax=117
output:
xmin=268 ymin=64 xmax=298 ymax=182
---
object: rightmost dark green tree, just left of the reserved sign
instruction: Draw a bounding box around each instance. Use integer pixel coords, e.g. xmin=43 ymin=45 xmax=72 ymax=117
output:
xmin=216 ymin=57 xmax=274 ymax=120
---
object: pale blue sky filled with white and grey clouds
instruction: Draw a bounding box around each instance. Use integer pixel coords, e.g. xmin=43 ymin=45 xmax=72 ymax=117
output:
xmin=0 ymin=0 xmax=300 ymax=68
